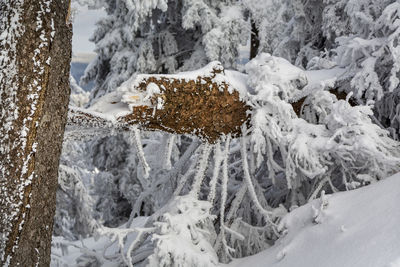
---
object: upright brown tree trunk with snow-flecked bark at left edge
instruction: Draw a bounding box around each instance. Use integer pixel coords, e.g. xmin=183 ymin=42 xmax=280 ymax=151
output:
xmin=0 ymin=0 xmax=72 ymax=266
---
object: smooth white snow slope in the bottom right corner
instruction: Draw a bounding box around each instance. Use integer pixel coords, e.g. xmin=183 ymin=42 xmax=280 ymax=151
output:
xmin=228 ymin=173 xmax=400 ymax=267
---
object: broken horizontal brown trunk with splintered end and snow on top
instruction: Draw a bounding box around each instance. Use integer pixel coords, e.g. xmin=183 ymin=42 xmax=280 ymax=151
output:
xmin=68 ymin=64 xmax=250 ymax=143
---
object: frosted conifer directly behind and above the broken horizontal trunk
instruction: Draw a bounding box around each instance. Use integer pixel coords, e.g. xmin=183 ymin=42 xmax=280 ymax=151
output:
xmin=79 ymin=0 xmax=247 ymax=99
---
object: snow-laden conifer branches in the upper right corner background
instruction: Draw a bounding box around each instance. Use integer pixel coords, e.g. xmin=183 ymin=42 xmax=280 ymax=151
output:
xmin=248 ymin=0 xmax=399 ymax=139
